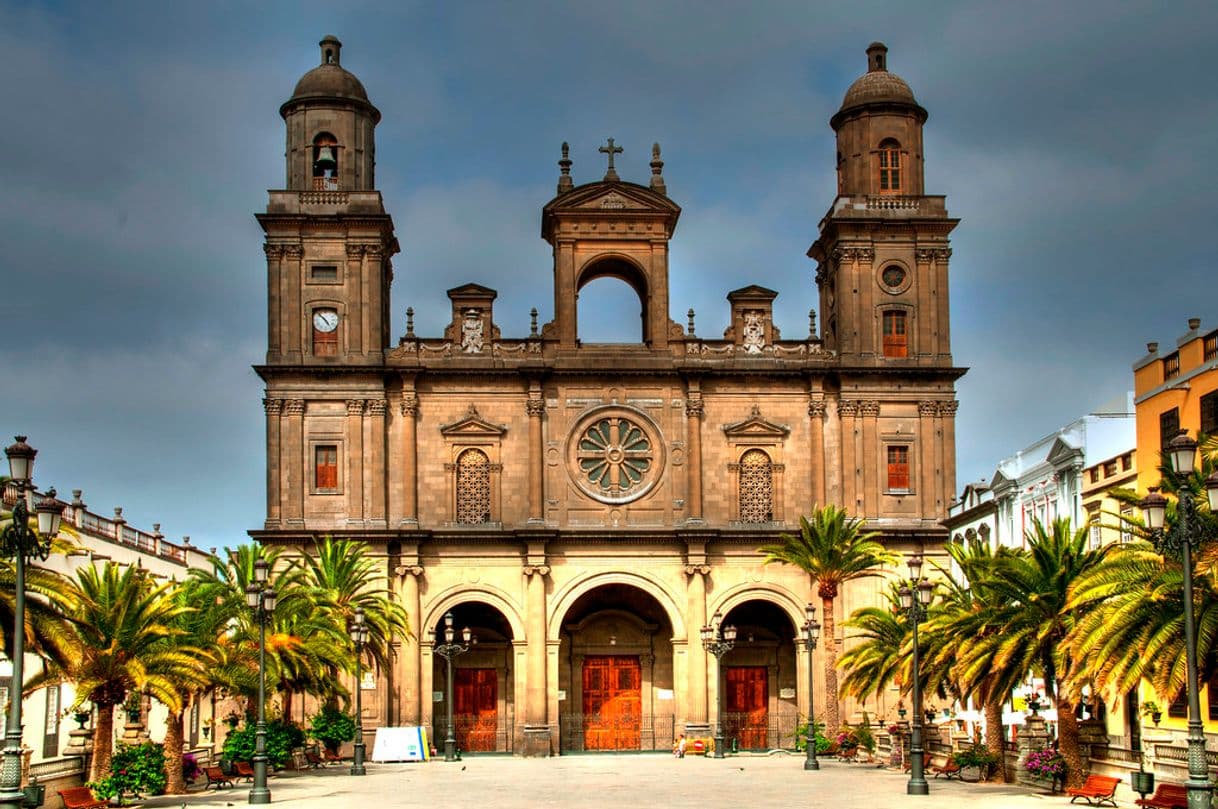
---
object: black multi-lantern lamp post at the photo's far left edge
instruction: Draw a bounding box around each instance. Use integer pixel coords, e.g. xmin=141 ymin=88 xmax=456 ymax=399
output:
xmin=0 ymin=435 xmax=66 ymax=809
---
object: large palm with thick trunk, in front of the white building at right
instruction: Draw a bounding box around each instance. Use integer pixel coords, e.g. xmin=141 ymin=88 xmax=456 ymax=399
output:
xmin=960 ymin=518 xmax=1107 ymax=785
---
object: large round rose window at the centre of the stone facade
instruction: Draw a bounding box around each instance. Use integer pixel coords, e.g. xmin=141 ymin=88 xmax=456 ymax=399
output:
xmin=568 ymin=407 xmax=664 ymax=503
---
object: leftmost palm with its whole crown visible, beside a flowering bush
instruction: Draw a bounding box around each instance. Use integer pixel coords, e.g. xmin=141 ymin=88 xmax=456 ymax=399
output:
xmin=27 ymin=562 xmax=202 ymax=781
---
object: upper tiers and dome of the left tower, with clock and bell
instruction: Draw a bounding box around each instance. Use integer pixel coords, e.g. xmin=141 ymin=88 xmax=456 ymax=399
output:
xmin=258 ymin=37 xmax=397 ymax=366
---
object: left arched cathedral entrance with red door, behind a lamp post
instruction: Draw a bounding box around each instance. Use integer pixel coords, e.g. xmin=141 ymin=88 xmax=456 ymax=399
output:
xmin=430 ymin=601 xmax=515 ymax=753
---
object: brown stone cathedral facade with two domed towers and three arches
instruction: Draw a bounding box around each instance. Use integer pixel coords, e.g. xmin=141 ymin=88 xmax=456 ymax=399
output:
xmin=251 ymin=37 xmax=963 ymax=755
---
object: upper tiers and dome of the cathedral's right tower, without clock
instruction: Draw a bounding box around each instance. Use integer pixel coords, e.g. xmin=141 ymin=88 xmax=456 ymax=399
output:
xmin=808 ymin=43 xmax=959 ymax=367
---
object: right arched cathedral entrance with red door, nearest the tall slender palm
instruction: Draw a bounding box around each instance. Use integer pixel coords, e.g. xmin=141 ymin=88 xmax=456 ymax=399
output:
xmin=719 ymin=601 xmax=799 ymax=751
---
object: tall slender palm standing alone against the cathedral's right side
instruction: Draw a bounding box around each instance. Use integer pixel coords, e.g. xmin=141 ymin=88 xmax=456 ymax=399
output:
xmin=758 ymin=506 xmax=898 ymax=730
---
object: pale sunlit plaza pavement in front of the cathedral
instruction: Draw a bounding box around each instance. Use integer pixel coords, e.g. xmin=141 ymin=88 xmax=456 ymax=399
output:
xmin=133 ymin=754 xmax=1138 ymax=809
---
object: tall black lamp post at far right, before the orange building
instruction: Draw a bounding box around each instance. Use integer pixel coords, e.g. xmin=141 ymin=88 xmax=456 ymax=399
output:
xmin=1140 ymin=433 xmax=1218 ymax=809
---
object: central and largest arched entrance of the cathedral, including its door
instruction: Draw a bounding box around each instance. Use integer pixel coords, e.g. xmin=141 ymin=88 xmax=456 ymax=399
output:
xmin=558 ymin=584 xmax=676 ymax=753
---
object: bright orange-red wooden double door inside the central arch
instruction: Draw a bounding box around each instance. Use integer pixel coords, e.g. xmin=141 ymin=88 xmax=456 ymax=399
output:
xmin=583 ymin=655 xmax=643 ymax=751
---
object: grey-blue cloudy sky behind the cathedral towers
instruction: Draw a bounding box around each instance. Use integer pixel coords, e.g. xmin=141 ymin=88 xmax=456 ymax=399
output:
xmin=0 ymin=0 xmax=1218 ymax=547
